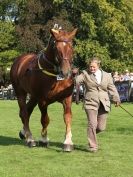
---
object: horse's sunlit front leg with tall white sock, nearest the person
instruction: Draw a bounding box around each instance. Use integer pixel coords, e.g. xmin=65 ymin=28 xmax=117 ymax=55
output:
xmin=63 ymin=96 xmax=73 ymax=152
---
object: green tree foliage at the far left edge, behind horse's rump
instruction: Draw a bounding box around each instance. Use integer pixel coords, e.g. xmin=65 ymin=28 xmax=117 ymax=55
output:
xmin=0 ymin=0 xmax=20 ymax=77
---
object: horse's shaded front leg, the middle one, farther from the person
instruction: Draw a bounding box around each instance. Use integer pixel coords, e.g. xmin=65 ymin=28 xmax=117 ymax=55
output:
xmin=38 ymin=103 xmax=49 ymax=147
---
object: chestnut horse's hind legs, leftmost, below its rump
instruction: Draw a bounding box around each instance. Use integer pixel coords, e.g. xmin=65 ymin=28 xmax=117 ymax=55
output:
xmin=18 ymin=95 xmax=37 ymax=147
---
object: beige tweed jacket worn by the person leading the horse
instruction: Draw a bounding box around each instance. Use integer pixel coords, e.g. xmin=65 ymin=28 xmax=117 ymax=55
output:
xmin=76 ymin=70 xmax=120 ymax=112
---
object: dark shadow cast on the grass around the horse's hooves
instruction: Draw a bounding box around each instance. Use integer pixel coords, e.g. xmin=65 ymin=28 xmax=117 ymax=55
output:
xmin=0 ymin=136 xmax=87 ymax=152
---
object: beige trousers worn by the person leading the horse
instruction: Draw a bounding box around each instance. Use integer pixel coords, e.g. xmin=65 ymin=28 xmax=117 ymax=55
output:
xmin=85 ymin=103 xmax=108 ymax=150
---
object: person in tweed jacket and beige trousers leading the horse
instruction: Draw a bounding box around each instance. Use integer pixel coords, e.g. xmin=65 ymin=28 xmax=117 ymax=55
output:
xmin=74 ymin=57 xmax=120 ymax=152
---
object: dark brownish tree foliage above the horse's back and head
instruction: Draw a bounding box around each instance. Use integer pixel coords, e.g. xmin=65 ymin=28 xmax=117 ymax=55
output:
xmin=15 ymin=0 xmax=72 ymax=52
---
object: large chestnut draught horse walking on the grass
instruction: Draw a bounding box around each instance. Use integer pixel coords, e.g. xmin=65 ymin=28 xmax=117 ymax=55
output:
xmin=10 ymin=29 xmax=77 ymax=151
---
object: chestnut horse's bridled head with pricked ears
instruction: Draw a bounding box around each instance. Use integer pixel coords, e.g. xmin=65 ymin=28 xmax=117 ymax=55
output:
xmin=51 ymin=29 xmax=77 ymax=78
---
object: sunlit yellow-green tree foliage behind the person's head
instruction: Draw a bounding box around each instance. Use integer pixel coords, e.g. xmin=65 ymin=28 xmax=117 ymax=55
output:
xmin=69 ymin=0 xmax=133 ymax=71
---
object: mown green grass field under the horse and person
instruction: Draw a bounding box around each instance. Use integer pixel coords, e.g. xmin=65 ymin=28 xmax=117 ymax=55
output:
xmin=0 ymin=100 xmax=133 ymax=177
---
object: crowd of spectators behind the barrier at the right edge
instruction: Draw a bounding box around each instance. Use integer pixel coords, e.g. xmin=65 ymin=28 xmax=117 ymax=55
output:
xmin=112 ymin=70 xmax=133 ymax=82
